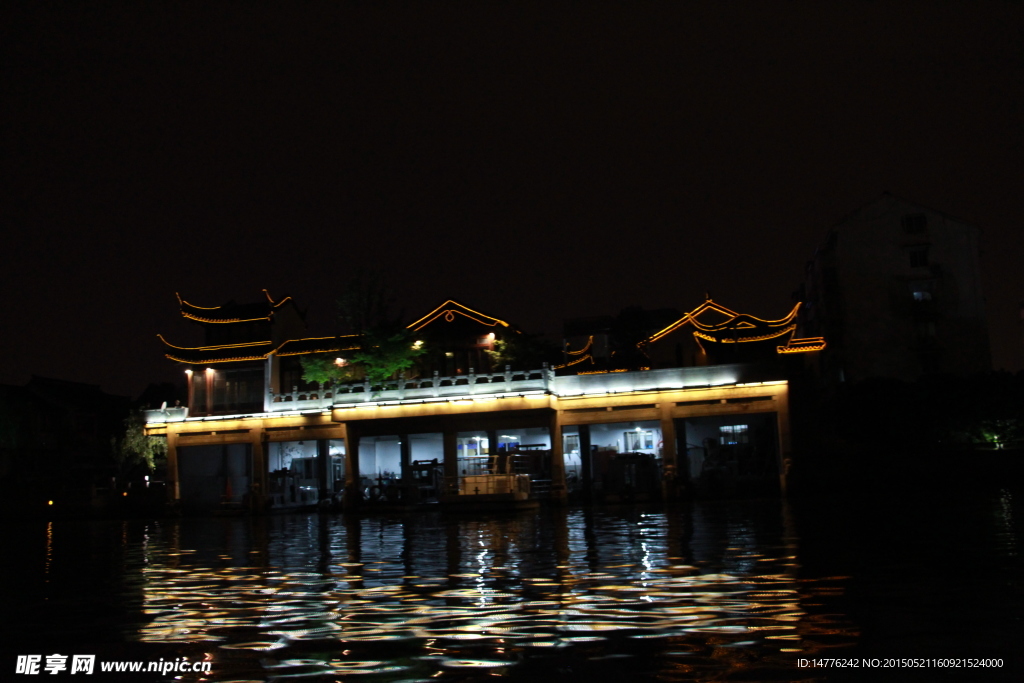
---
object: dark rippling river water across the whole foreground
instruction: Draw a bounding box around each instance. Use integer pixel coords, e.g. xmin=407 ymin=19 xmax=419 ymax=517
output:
xmin=0 ymin=485 xmax=1024 ymax=681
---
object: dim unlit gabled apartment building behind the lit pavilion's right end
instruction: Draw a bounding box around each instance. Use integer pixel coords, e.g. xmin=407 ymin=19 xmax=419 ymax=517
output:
xmin=800 ymin=194 xmax=991 ymax=382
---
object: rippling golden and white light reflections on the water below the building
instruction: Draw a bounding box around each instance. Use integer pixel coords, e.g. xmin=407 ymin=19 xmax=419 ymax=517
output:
xmin=117 ymin=501 xmax=856 ymax=680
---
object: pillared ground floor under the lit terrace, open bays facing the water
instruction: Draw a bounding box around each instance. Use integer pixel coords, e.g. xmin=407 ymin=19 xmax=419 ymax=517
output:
xmin=148 ymin=382 xmax=790 ymax=512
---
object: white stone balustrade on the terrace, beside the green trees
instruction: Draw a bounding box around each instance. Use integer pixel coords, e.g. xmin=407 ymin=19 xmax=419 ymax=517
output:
xmin=267 ymin=364 xmax=555 ymax=413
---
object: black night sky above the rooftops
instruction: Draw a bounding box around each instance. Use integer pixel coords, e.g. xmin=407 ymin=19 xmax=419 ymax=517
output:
xmin=0 ymin=2 xmax=1024 ymax=395
